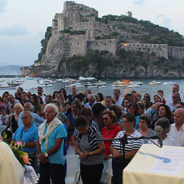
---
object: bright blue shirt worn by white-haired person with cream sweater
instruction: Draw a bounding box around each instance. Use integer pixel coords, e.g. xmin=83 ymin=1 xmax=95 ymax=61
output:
xmin=41 ymin=123 xmax=67 ymax=165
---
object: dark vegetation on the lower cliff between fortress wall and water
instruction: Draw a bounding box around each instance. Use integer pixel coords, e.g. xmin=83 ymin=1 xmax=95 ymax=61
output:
xmin=57 ymin=49 xmax=184 ymax=79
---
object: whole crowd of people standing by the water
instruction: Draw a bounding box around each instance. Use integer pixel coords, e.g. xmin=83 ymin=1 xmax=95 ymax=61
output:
xmin=0 ymin=84 xmax=184 ymax=184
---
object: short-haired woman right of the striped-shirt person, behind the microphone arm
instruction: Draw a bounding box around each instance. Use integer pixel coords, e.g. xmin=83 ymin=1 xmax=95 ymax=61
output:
xmin=139 ymin=114 xmax=155 ymax=144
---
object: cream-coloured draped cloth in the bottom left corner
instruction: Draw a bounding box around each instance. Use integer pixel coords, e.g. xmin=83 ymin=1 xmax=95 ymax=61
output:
xmin=0 ymin=141 xmax=24 ymax=184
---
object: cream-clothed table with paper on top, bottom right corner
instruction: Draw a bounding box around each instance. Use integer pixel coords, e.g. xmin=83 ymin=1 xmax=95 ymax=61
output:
xmin=123 ymin=144 xmax=184 ymax=184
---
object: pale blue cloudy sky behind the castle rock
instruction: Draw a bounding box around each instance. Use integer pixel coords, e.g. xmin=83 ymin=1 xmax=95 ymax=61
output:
xmin=0 ymin=0 xmax=184 ymax=66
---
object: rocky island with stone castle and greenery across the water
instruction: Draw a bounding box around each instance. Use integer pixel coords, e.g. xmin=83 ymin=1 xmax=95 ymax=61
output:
xmin=22 ymin=1 xmax=184 ymax=78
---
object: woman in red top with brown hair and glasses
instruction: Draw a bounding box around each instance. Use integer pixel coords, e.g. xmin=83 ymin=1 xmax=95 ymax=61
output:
xmin=101 ymin=111 xmax=121 ymax=183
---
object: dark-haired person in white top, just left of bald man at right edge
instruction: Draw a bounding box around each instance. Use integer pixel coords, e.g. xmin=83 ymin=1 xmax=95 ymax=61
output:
xmin=148 ymin=117 xmax=176 ymax=146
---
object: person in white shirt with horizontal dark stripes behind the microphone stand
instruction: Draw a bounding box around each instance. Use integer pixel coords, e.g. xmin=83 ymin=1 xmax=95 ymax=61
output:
xmin=111 ymin=113 xmax=143 ymax=184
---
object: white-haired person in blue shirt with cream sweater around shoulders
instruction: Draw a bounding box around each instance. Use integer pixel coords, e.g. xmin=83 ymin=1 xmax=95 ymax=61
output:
xmin=37 ymin=103 xmax=67 ymax=184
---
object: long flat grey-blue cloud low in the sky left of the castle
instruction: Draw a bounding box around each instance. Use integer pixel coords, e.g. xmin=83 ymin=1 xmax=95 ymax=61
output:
xmin=0 ymin=25 xmax=29 ymax=36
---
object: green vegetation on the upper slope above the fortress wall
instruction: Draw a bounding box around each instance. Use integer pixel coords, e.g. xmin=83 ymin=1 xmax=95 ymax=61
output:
xmin=96 ymin=15 xmax=184 ymax=46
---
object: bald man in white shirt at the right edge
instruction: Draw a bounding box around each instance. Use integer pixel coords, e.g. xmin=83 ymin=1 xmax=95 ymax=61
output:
xmin=169 ymin=108 xmax=184 ymax=146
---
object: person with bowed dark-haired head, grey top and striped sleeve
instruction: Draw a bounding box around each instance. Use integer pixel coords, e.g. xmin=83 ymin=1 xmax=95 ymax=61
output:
xmin=75 ymin=116 xmax=104 ymax=184
